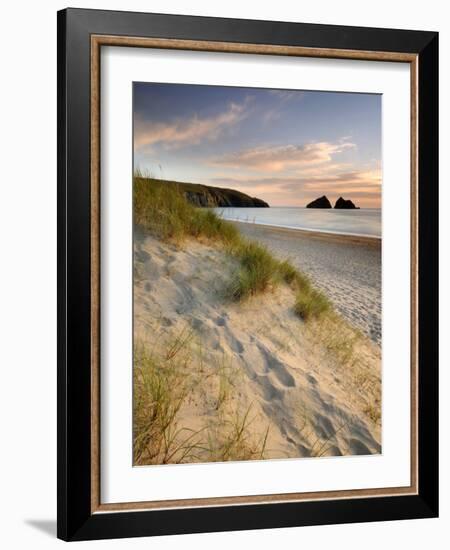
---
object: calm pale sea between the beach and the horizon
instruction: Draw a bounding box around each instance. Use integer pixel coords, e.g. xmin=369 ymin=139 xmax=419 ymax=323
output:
xmin=215 ymin=206 xmax=381 ymax=238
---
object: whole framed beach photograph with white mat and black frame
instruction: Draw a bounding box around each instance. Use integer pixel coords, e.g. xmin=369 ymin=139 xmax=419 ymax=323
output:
xmin=58 ymin=9 xmax=438 ymax=540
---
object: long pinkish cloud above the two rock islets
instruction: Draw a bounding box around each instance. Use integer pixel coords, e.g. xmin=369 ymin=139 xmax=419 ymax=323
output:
xmin=210 ymin=140 xmax=355 ymax=172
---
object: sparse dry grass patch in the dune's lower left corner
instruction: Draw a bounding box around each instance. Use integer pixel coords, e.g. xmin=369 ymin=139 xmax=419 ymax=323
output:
xmin=133 ymin=332 xmax=269 ymax=465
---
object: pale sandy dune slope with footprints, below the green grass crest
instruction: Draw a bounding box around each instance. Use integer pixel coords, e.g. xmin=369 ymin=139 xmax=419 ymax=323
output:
xmin=134 ymin=231 xmax=381 ymax=466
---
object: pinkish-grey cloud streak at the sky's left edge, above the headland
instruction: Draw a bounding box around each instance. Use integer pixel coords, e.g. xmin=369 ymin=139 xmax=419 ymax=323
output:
xmin=134 ymin=103 xmax=246 ymax=149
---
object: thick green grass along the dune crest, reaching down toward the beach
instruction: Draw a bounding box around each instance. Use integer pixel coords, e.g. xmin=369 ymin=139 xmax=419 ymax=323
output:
xmin=133 ymin=172 xmax=331 ymax=321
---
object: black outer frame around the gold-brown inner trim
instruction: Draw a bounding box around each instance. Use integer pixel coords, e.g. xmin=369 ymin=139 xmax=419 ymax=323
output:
xmin=57 ymin=9 xmax=438 ymax=540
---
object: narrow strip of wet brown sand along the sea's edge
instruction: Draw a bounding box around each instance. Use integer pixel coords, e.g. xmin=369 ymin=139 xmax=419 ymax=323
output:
xmin=230 ymin=218 xmax=382 ymax=249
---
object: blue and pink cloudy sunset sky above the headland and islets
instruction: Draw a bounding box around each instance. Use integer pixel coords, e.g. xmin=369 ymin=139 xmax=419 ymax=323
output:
xmin=133 ymin=82 xmax=381 ymax=208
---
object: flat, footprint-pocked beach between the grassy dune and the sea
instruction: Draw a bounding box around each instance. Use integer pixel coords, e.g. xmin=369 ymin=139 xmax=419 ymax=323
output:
xmin=234 ymin=222 xmax=381 ymax=345
